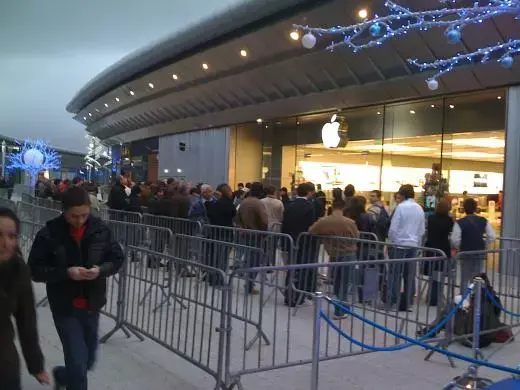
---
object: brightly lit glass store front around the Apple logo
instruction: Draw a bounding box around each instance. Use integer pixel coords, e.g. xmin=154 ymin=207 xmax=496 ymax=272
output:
xmin=229 ymin=90 xmax=506 ymax=228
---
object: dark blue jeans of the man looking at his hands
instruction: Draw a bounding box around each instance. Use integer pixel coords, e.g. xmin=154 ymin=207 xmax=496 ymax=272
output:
xmin=53 ymin=309 xmax=99 ymax=390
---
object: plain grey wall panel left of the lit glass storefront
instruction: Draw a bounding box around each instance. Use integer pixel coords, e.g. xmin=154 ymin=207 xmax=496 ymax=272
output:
xmin=158 ymin=127 xmax=230 ymax=185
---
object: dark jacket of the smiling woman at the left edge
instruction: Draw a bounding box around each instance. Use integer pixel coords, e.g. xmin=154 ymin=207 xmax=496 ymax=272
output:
xmin=0 ymin=253 xmax=43 ymax=388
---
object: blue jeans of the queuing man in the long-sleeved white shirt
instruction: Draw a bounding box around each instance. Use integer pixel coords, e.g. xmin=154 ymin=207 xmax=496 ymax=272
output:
xmin=388 ymin=247 xmax=418 ymax=311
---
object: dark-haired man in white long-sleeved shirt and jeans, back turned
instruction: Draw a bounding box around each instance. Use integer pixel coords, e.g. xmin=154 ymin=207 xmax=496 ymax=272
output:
xmin=388 ymin=184 xmax=425 ymax=311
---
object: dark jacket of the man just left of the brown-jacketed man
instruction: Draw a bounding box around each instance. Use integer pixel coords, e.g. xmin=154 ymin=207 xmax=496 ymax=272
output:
xmin=282 ymin=198 xmax=317 ymax=244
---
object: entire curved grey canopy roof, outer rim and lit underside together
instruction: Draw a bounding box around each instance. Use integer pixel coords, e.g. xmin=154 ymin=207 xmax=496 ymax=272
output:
xmin=68 ymin=0 xmax=520 ymax=143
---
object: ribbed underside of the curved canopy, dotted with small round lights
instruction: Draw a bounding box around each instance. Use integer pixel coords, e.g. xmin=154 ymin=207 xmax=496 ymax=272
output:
xmin=76 ymin=0 xmax=520 ymax=142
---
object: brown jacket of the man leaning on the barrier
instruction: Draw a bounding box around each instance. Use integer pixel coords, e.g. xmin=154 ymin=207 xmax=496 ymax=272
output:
xmin=309 ymin=213 xmax=359 ymax=258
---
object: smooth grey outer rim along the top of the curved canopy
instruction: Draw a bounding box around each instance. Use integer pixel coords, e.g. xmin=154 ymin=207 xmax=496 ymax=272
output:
xmin=67 ymin=0 xmax=322 ymax=114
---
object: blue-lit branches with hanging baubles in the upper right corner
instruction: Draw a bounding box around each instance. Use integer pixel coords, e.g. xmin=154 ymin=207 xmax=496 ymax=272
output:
xmin=294 ymin=0 xmax=520 ymax=90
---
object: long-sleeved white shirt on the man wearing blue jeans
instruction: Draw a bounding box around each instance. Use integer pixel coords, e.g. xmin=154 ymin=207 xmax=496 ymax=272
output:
xmin=388 ymin=199 xmax=425 ymax=246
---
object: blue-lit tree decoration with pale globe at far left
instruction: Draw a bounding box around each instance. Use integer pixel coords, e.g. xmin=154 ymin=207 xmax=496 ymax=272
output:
xmin=6 ymin=139 xmax=61 ymax=183
